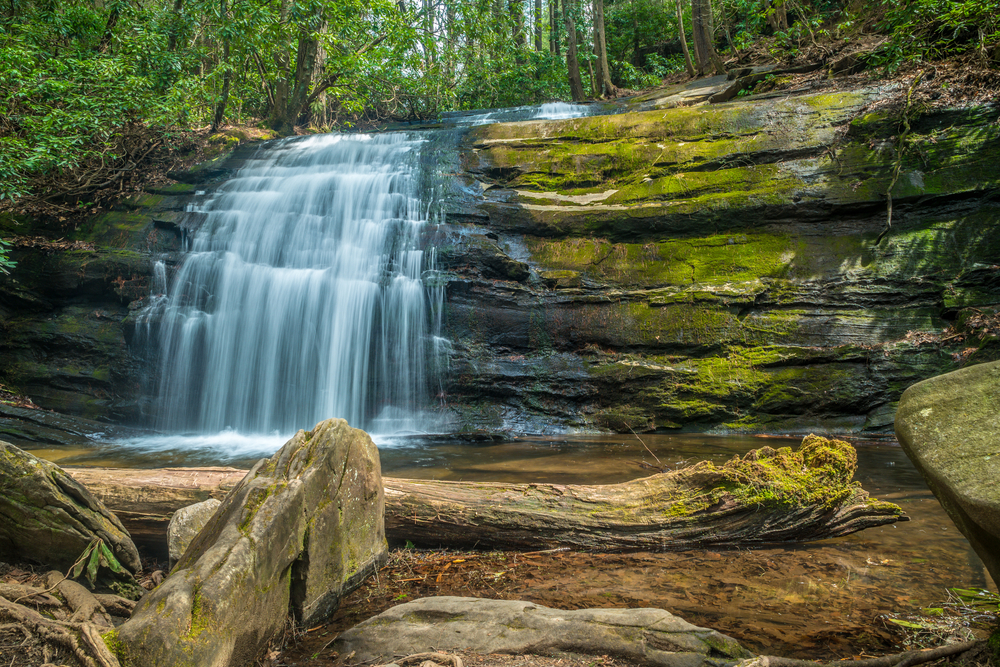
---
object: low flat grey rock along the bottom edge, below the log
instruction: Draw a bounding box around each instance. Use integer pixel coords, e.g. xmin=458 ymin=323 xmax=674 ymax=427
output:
xmin=333 ymin=597 xmax=750 ymax=667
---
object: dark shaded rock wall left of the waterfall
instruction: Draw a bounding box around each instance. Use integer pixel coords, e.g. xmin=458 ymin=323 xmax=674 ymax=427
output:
xmin=0 ymin=142 xmax=270 ymax=428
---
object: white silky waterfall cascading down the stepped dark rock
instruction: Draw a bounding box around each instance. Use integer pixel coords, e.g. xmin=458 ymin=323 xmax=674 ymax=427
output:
xmin=157 ymin=133 xmax=442 ymax=433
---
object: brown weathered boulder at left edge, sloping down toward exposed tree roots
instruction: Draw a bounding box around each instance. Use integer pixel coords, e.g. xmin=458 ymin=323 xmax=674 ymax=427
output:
xmin=0 ymin=441 xmax=141 ymax=572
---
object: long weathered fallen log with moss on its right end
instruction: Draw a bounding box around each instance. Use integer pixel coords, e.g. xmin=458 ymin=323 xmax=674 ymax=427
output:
xmin=68 ymin=436 xmax=906 ymax=551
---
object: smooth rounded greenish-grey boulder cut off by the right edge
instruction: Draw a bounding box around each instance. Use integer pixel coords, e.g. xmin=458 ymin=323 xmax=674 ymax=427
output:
xmin=896 ymin=363 xmax=1000 ymax=582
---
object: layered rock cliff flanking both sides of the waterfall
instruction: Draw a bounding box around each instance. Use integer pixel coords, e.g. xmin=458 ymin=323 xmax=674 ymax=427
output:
xmin=0 ymin=81 xmax=1000 ymax=437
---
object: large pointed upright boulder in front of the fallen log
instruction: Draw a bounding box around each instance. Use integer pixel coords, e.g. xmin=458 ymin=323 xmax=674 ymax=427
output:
xmin=118 ymin=419 xmax=386 ymax=667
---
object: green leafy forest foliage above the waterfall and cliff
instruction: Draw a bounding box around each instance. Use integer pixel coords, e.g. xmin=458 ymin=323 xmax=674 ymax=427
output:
xmin=0 ymin=0 xmax=1000 ymax=211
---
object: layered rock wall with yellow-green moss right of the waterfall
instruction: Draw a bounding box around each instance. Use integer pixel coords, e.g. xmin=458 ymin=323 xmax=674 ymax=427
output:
xmin=442 ymin=90 xmax=1000 ymax=432
